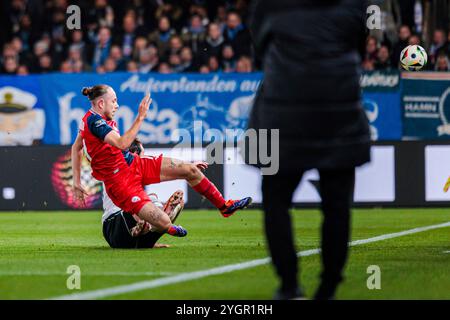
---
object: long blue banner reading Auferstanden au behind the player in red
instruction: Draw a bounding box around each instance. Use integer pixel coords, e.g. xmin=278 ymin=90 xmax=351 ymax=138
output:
xmin=40 ymin=73 xmax=262 ymax=145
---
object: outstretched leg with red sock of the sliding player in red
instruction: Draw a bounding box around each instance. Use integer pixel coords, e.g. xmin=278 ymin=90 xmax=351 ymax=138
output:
xmin=160 ymin=157 xmax=252 ymax=217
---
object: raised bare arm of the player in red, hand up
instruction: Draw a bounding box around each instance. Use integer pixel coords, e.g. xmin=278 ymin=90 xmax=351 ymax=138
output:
xmin=105 ymin=94 xmax=152 ymax=150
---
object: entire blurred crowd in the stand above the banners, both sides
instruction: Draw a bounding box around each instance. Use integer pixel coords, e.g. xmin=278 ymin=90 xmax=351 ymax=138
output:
xmin=0 ymin=0 xmax=450 ymax=74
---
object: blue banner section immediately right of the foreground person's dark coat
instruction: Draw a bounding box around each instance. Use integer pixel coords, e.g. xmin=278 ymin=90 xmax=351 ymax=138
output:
xmin=360 ymin=71 xmax=402 ymax=141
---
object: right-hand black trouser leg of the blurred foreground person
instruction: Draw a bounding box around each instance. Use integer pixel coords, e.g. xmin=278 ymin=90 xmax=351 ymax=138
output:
xmin=315 ymin=168 xmax=355 ymax=299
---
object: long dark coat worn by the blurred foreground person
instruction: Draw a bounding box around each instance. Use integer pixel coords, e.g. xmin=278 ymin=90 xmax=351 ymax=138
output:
xmin=249 ymin=0 xmax=370 ymax=171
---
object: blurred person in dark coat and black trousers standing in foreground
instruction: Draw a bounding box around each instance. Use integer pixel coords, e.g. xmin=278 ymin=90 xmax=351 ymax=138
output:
xmin=247 ymin=0 xmax=370 ymax=299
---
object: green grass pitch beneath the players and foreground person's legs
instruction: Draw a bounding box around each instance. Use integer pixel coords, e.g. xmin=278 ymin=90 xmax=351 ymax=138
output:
xmin=0 ymin=209 xmax=450 ymax=299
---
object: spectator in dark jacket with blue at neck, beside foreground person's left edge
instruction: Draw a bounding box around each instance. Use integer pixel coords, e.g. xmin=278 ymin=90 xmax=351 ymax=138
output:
xmin=223 ymin=11 xmax=251 ymax=57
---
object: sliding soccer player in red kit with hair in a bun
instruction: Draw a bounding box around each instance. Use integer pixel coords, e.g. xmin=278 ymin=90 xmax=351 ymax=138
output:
xmin=72 ymin=85 xmax=252 ymax=237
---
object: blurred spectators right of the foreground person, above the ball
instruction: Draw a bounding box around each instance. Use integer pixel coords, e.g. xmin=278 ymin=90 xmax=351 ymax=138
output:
xmin=362 ymin=0 xmax=450 ymax=71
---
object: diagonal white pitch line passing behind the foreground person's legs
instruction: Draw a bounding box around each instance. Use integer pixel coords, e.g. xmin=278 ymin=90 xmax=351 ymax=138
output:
xmin=51 ymin=221 xmax=450 ymax=300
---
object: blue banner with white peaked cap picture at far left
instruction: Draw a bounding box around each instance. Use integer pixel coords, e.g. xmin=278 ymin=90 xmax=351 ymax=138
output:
xmin=0 ymin=76 xmax=46 ymax=146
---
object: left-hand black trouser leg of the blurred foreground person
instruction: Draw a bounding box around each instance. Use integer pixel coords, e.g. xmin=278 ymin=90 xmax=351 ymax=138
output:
xmin=262 ymin=172 xmax=303 ymax=299
